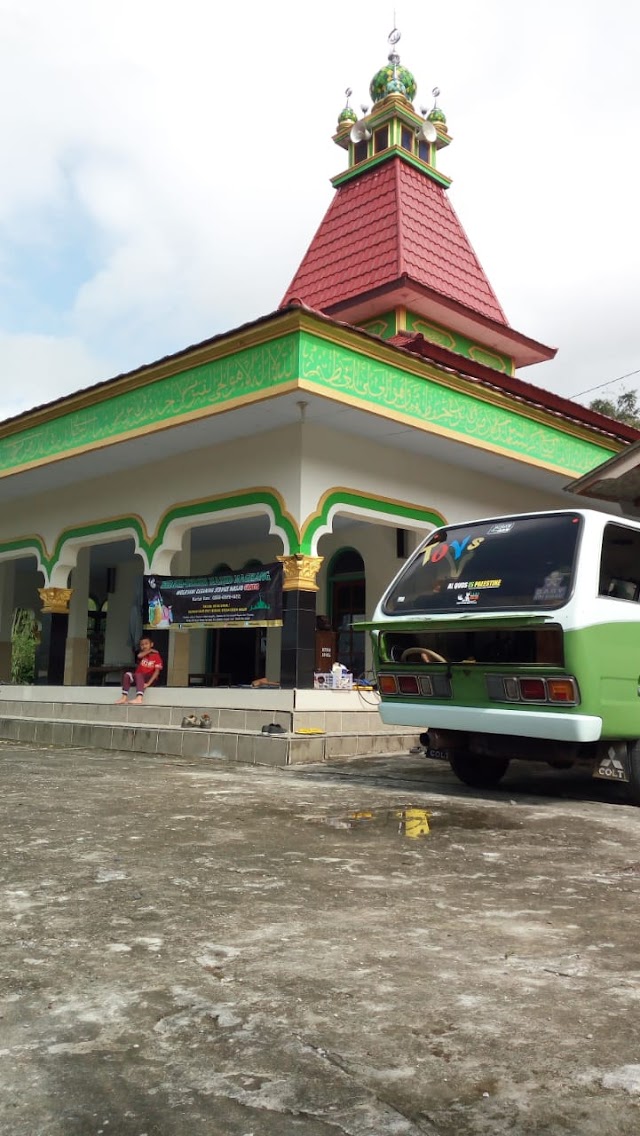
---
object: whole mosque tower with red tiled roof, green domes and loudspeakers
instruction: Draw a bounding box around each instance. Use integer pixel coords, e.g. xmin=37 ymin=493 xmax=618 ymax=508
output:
xmin=282 ymin=22 xmax=552 ymax=374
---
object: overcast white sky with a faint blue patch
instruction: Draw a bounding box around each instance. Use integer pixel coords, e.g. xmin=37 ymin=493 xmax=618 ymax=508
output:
xmin=0 ymin=0 xmax=640 ymax=418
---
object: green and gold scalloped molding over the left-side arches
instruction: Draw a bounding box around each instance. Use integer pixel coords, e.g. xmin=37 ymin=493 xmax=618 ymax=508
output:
xmin=0 ymin=488 xmax=300 ymax=576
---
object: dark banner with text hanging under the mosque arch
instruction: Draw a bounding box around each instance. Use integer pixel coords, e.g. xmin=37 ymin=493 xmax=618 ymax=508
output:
xmin=143 ymin=561 xmax=282 ymax=630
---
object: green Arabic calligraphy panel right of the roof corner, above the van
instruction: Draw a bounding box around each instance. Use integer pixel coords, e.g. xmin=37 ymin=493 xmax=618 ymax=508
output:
xmin=300 ymin=333 xmax=613 ymax=476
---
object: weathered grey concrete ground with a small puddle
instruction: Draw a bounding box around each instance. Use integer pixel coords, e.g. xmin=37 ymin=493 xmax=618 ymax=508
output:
xmin=0 ymin=743 xmax=640 ymax=1136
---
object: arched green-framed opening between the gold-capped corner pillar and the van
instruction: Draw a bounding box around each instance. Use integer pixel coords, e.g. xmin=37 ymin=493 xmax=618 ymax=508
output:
xmin=327 ymin=549 xmax=366 ymax=676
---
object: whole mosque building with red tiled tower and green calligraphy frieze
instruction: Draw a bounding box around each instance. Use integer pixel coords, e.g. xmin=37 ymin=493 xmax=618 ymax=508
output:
xmin=0 ymin=32 xmax=640 ymax=736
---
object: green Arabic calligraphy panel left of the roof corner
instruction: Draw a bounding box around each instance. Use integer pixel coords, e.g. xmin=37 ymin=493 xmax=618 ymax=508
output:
xmin=0 ymin=333 xmax=298 ymax=470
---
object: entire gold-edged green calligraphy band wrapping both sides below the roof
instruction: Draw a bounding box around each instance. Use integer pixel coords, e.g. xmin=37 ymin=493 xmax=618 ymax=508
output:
xmin=0 ymin=310 xmax=622 ymax=486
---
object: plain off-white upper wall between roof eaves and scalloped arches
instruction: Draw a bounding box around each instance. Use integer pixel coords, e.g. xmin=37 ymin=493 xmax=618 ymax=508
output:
xmin=0 ymin=423 xmax=575 ymax=577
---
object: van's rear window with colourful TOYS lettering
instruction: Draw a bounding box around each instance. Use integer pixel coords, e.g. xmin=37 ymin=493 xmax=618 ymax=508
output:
xmin=383 ymin=512 xmax=582 ymax=615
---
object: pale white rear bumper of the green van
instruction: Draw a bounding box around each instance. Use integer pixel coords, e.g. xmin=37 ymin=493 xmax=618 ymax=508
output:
xmin=380 ymin=702 xmax=602 ymax=742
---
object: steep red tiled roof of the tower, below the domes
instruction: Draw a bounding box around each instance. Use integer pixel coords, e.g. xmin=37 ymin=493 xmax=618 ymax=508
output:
xmin=282 ymin=158 xmax=508 ymax=326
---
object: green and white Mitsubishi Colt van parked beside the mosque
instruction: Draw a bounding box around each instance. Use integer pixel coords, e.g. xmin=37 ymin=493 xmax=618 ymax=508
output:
xmin=360 ymin=509 xmax=640 ymax=803
